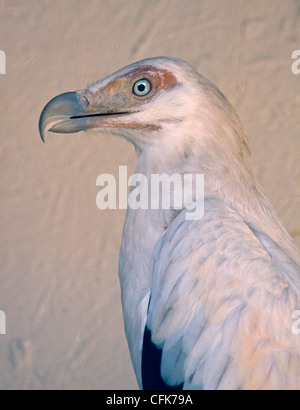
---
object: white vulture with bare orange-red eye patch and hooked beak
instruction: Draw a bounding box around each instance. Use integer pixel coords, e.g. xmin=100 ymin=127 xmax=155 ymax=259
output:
xmin=39 ymin=57 xmax=300 ymax=390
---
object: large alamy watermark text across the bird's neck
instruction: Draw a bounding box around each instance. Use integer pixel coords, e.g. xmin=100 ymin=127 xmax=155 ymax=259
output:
xmin=96 ymin=166 xmax=204 ymax=220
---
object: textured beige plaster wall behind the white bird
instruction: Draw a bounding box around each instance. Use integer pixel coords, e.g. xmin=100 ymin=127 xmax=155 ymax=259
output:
xmin=0 ymin=0 xmax=300 ymax=389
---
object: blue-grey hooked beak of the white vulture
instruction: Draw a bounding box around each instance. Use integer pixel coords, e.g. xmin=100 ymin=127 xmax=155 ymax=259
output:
xmin=39 ymin=91 xmax=130 ymax=142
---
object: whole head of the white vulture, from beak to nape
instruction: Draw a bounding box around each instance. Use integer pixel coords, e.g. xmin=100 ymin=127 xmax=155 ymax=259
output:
xmin=39 ymin=57 xmax=251 ymax=175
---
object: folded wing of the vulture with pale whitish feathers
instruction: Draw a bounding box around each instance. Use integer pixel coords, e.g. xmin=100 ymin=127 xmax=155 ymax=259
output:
xmin=147 ymin=200 xmax=300 ymax=389
